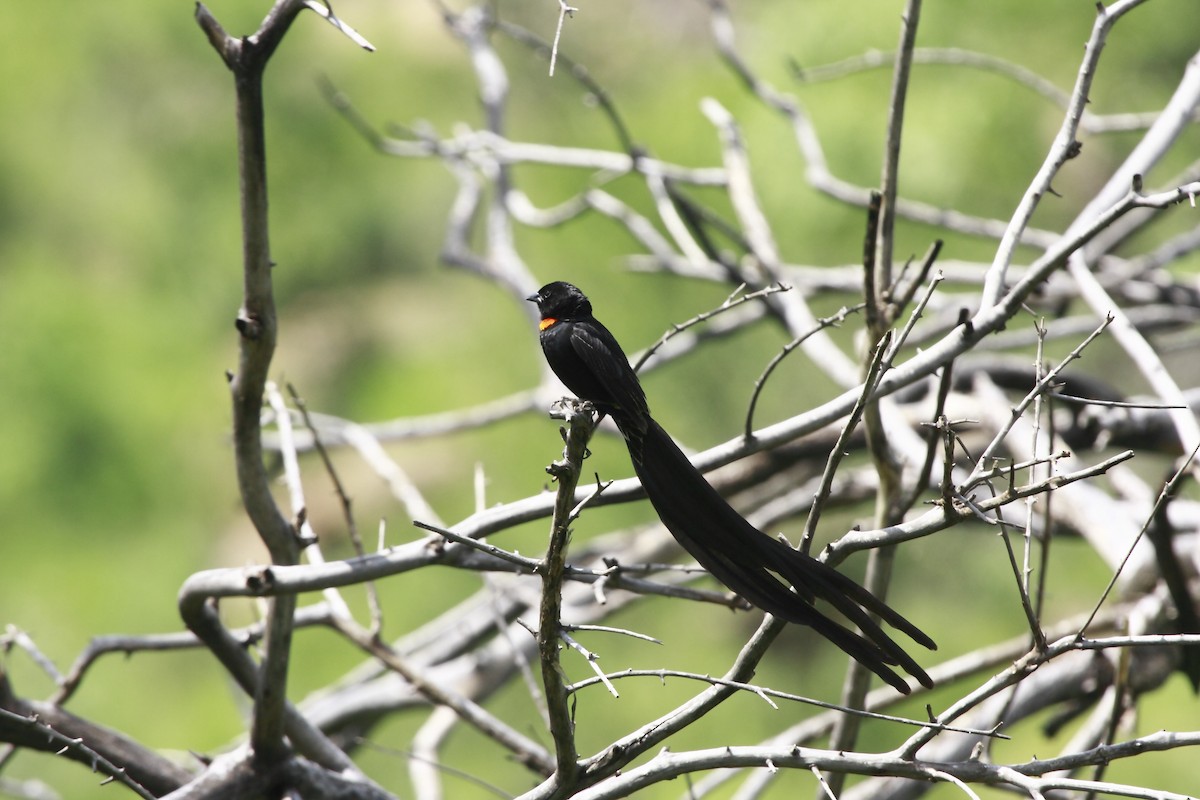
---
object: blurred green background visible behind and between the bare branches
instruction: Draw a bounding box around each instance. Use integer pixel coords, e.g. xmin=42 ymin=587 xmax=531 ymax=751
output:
xmin=0 ymin=0 xmax=1200 ymax=798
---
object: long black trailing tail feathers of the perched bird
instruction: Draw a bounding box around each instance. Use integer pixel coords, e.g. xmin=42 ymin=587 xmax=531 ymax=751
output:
xmin=614 ymin=416 xmax=937 ymax=693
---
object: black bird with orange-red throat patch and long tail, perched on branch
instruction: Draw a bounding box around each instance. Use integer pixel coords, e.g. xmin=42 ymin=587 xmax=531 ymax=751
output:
xmin=527 ymin=281 xmax=937 ymax=694
